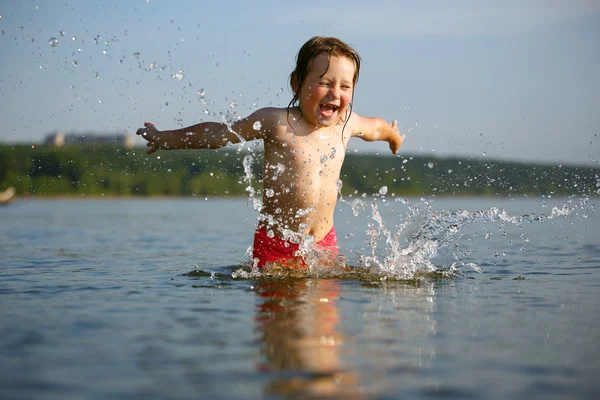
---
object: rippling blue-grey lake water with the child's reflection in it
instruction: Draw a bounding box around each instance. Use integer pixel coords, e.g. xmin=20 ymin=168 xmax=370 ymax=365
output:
xmin=0 ymin=198 xmax=600 ymax=399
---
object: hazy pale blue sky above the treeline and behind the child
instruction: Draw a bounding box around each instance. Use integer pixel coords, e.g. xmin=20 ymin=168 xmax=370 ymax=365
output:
xmin=0 ymin=0 xmax=600 ymax=167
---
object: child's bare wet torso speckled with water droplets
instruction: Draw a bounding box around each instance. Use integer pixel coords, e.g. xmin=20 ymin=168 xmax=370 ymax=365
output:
xmin=259 ymin=109 xmax=350 ymax=241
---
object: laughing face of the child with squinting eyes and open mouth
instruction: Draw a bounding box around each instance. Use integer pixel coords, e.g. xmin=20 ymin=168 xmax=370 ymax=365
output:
xmin=299 ymin=53 xmax=356 ymax=127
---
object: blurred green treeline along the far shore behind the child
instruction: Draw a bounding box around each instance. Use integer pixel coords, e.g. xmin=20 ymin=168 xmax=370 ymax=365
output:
xmin=0 ymin=145 xmax=600 ymax=196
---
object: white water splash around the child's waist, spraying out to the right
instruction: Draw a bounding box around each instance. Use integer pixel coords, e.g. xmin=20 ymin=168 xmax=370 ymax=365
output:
xmin=232 ymin=198 xmax=595 ymax=282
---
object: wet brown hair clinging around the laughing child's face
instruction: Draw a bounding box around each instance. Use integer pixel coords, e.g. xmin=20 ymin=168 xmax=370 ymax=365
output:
xmin=288 ymin=36 xmax=360 ymax=134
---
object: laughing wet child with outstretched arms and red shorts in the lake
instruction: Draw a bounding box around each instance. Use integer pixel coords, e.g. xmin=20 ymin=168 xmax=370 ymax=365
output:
xmin=137 ymin=37 xmax=404 ymax=268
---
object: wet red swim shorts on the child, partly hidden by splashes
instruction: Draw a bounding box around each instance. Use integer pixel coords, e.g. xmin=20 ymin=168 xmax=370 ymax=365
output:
xmin=252 ymin=227 xmax=338 ymax=268
